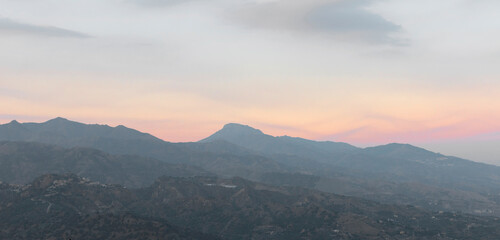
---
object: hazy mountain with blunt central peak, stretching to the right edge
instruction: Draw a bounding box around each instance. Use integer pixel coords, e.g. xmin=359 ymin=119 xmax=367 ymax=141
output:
xmin=201 ymin=124 xmax=500 ymax=216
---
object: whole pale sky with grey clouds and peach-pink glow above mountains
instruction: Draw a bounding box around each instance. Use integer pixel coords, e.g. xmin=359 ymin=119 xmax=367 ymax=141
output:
xmin=0 ymin=0 xmax=500 ymax=165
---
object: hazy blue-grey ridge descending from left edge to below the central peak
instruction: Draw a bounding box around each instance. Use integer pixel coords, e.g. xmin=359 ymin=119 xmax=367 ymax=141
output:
xmin=0 ymin=118 xmax=287 ymax=179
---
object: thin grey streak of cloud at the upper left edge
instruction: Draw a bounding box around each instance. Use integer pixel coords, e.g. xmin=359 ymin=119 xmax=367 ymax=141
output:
xmin=0 ymin=18 xmax=90 ymax=38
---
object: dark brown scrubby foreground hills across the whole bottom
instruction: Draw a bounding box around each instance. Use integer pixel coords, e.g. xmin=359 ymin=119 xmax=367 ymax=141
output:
xmin=0 ymin=175 xmax=500 ymax=239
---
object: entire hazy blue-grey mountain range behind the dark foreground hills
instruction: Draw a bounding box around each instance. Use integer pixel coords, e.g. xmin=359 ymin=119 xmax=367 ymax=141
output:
xmin=0 ymin=118 xmax=500 ymax=216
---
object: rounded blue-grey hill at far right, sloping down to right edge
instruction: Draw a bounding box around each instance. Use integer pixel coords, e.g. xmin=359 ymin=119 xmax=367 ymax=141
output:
xmin=332 ymin=144 xmax=500 ymax=194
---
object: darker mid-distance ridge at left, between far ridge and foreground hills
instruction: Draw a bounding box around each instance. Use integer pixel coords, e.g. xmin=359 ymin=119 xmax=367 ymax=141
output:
xmin=0 ymin=142 xmax=213 ymax=187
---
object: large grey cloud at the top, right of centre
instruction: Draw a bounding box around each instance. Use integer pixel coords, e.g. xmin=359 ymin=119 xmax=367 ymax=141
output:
xmin=233 ymin=0 xmax=406 ymax=45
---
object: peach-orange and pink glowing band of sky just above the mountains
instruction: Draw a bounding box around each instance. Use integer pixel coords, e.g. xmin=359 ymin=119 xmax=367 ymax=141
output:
xmin=0 ymin=75 xmax=500 ymax=145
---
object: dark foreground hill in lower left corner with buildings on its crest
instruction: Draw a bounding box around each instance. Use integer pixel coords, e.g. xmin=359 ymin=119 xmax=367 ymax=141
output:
xmin=0 ymin=175 xmax=217 ymax=240
